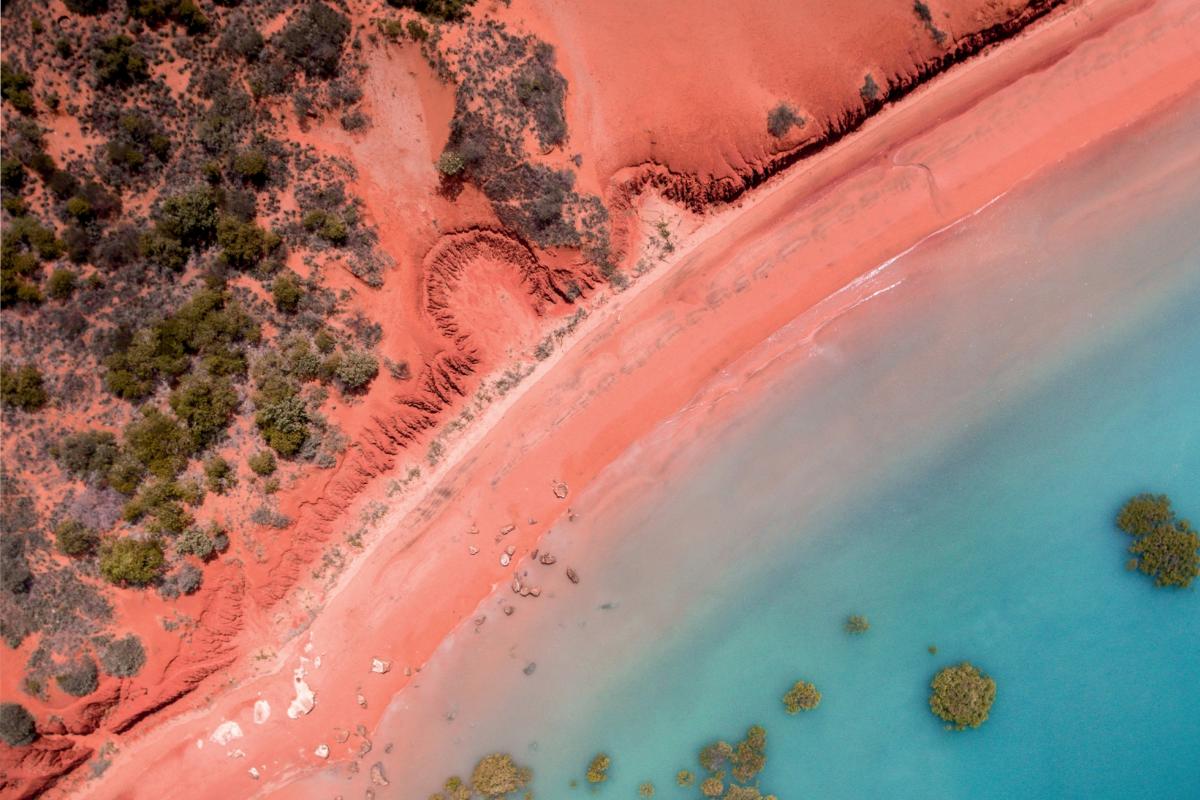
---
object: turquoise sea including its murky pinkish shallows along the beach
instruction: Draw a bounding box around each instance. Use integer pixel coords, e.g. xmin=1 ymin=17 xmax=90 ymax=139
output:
xmin=333 ymin=109 xmax=1200 ymax=800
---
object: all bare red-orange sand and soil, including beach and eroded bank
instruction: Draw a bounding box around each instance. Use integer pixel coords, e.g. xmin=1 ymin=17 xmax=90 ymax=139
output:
xmin=0 ymin=0 xmax=1200 ymax=798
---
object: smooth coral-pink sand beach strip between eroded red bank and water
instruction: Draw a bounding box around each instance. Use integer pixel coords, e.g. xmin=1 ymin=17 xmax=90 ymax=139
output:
xmin=68 ymin=0 xmax=1200 ymax=798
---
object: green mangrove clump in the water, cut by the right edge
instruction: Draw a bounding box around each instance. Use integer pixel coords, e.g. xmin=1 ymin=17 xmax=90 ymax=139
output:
xmin=1116 ymin=494 xmax=1200 ymax=589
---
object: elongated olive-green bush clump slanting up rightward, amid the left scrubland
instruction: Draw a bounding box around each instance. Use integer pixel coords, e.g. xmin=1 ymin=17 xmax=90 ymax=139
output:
xmin=104 ymin=289 xmax=259 ymax=399
